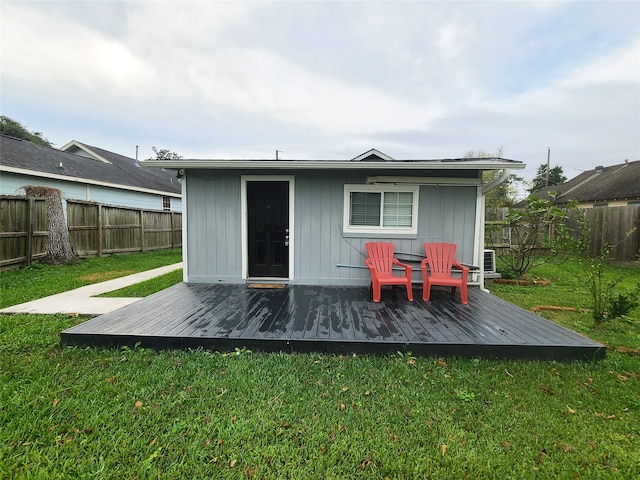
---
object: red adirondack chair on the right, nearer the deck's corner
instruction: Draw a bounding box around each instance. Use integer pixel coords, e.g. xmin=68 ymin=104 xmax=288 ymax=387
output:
xmin=420 ymin=243 xmax=469 ymax=305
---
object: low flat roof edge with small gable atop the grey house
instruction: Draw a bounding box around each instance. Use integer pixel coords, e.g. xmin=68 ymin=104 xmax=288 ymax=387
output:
xmin=140 ymin=149 xmax=526 ymax=170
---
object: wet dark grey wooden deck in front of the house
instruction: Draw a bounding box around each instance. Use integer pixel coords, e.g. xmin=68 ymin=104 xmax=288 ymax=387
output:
xmin=61 ymin=283 xmax=606 ymax=360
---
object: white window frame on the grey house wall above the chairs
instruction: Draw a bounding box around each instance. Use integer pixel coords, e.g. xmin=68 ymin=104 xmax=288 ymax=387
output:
xmin=342 ymin=184 xmax=420 ymax=235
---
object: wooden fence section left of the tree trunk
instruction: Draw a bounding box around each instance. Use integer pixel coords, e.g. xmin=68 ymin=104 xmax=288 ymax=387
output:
xmin=0 ymin=196 xmax=49 ymax=267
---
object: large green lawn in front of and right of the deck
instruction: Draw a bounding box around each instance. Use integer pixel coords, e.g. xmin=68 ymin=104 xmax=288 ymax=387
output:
xmin=0 ymin=251 xmax=640 ymax=479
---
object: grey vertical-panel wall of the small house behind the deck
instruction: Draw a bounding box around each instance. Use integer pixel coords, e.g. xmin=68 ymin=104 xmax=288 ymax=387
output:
xmin=186 ymin=170 xmax=477 ymax=285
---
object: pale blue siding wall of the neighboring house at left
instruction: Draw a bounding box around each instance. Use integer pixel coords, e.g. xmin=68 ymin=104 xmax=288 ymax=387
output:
xmin=0 ymin=172 xmax=182 ymax=212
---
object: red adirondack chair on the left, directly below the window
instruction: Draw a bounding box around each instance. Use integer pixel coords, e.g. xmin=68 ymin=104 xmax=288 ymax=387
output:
xmin=364 ymin=242 xmax=413 ymax=302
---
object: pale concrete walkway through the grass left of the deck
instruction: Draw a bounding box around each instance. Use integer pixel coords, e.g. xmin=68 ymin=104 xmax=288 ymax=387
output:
xmin=0 ymin=262 xmax=182 ymax=315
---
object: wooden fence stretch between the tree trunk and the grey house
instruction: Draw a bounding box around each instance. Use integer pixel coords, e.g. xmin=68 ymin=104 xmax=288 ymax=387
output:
xmin=67 ymin=200 xmax=182 ymax=257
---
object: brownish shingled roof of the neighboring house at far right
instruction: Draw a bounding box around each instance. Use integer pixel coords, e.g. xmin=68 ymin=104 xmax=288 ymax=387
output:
xmin=536 ymin=160 xmax=640 ymax=204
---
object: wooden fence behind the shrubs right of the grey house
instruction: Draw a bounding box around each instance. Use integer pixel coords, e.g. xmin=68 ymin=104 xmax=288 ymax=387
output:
xmin=485 ymin=205 xmax=640 ymax=262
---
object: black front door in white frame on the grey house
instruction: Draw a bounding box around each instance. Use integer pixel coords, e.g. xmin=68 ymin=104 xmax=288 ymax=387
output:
xmin=247 ymin=181 xmax=289 ymax=278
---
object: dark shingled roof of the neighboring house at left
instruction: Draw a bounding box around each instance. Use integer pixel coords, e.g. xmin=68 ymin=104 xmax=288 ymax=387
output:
xmin=0 ymin=135 xmax=181 ymax=196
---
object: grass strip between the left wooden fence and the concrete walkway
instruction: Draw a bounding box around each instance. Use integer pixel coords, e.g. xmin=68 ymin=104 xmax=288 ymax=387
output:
xmin=0 ymin=248 xmax=182 ymax=308
